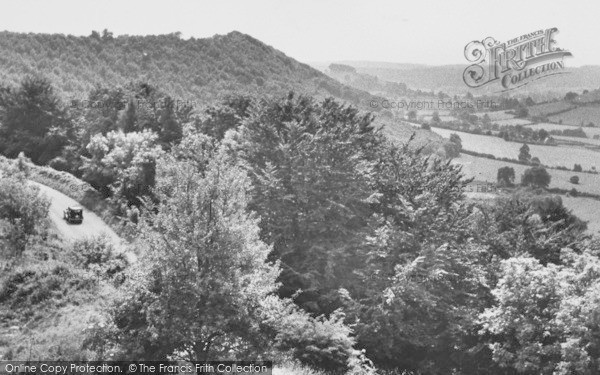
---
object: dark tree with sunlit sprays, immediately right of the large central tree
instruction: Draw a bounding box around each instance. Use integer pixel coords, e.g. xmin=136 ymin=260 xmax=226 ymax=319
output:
xmin=346 ymin=146 xmax=483 ymax=373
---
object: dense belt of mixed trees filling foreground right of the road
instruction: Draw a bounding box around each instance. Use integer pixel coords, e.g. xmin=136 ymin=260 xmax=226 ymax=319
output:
xmin=0 ymin=77 xmax=600 ymax=374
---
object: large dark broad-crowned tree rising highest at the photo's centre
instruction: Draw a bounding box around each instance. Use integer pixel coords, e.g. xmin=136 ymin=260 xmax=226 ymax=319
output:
xmin=232 ymin=94 xmax=384 ymax=314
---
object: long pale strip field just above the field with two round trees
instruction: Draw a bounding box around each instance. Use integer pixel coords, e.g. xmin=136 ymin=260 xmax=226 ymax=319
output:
xmin=431 ymin=128 xmax=600 ymax=169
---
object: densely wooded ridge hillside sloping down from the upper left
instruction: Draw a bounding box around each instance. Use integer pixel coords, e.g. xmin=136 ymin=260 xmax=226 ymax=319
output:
xmin=0 ymin=31 xmax=378 ymax=105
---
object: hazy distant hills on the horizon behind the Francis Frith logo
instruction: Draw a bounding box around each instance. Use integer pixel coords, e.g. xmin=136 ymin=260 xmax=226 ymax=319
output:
xmin=312 ymin=61 xmax=600 ymax=96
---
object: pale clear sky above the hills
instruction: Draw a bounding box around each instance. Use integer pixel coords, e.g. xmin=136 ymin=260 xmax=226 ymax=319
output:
xmin=0 ymin=0 xmax=600 ymax=66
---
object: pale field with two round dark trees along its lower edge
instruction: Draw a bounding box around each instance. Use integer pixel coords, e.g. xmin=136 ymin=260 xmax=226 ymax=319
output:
xmin=452 ymin=154 xmax=600 ymax=198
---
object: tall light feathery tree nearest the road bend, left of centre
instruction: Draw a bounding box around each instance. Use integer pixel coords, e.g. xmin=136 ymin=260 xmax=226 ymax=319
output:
xmin=113 ymin=151 xmax=278 ymax=360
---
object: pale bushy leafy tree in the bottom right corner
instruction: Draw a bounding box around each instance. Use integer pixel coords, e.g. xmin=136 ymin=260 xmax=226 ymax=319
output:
xmin=479 ymin=253 xmax=600 ymax=375
